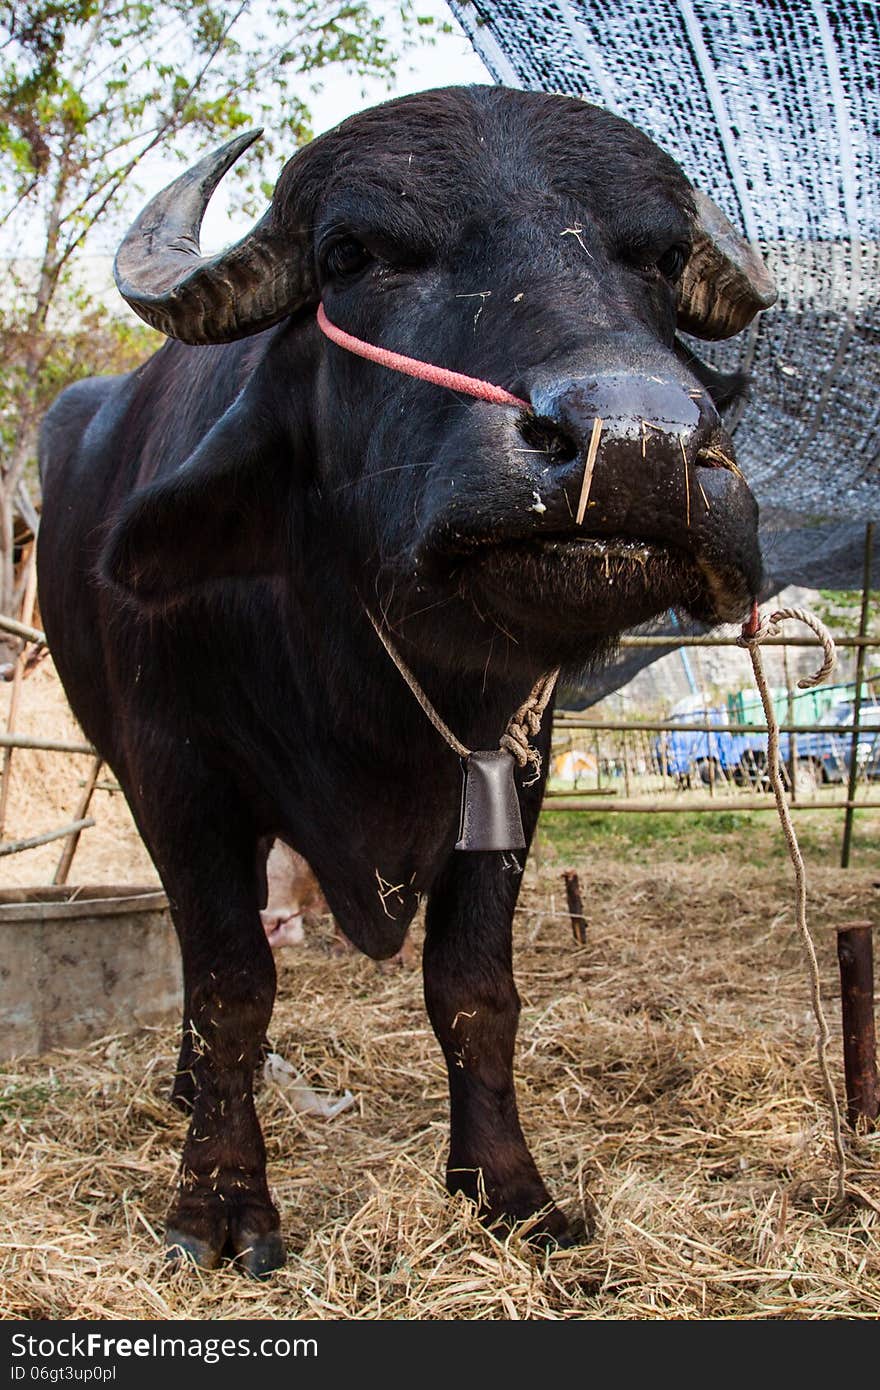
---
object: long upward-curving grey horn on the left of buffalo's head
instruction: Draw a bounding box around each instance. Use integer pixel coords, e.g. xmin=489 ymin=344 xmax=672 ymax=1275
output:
xmin=113 ymin=131 xmax=313 ymax=343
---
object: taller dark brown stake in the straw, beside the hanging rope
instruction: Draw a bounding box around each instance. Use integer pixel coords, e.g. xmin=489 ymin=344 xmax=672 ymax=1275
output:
xmin=837 ymin=922 xmax=880 ymax=1129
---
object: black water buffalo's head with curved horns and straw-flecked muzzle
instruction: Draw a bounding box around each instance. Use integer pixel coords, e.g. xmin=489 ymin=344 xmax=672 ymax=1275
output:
xmin=108 ymin=88 xmax=774 ymax=669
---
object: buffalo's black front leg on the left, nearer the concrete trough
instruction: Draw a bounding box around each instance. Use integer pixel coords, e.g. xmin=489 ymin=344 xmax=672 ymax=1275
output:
xmin=135 ymin=788 xmax=285 ymax=1276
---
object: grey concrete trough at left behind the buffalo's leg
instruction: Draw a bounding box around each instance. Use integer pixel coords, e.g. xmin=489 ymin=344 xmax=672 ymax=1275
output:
xmin=0 ymin=884 xmax=182 ymax=1058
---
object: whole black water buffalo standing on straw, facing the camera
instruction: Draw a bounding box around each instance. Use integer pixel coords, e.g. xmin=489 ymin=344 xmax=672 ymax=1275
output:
xmin=39 ymin=88 xmax=773 ymax=1273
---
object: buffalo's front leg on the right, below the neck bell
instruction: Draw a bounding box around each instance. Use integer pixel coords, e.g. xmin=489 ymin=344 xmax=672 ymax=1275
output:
xmin=423 ymin=852 xmax=569 ymax=1243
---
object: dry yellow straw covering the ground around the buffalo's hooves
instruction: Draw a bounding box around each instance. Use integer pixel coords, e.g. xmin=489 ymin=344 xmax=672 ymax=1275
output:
xmin=0 ymin=838 xmax=880 ymax=1319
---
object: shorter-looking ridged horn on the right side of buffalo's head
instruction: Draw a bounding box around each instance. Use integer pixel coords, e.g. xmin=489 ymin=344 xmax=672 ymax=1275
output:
xmin=678 ymin=189 xmax=776 ymax=338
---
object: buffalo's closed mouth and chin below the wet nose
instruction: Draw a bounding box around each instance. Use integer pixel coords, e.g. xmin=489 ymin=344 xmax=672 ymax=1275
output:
xmin=452 ymin=534 xmax=753 ymax=637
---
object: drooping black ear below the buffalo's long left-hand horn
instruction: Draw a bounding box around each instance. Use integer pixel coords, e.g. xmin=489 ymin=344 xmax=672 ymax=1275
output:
xmin=100 ymin=406 xmax=291 ymax=607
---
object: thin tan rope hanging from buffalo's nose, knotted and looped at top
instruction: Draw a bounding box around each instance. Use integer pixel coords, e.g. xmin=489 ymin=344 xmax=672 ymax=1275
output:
xmin=737 ymin=603 xmax=847 ymax=1205
